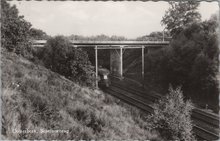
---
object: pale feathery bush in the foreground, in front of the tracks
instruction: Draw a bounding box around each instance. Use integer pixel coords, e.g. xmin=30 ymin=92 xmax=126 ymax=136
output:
xmin=147 ymin=88 xmax=195 ymax=140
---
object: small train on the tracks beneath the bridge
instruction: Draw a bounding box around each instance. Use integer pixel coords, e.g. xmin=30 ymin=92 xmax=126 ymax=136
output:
xmin=98 ymin=67 xmax=111 ymax=88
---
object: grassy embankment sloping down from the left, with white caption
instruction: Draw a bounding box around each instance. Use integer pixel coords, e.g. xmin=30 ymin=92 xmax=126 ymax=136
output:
xmin=1 ymin=51 xmax=158 ymax=140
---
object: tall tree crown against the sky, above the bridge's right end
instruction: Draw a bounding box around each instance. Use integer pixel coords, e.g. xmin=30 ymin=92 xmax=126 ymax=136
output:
xmin=161 ymin=1 xmax=201 ymax=36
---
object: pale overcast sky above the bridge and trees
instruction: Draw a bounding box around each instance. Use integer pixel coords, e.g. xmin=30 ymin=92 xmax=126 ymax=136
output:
xmin=10 ymin=1 xmax=219 ymax=38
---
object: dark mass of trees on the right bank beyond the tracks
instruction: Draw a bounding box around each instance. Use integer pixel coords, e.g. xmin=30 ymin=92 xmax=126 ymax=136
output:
xmin=146 ymin=16 xmax=219 ymax=111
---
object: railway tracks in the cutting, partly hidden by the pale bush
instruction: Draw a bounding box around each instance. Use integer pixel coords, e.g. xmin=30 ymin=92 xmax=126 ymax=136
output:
xmin=106 ymin=82 xmax=219 ymax=140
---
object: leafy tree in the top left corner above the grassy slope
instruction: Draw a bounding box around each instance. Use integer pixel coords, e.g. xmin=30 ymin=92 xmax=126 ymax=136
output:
xmin=1 ymin=0 xmax=31 ymax=56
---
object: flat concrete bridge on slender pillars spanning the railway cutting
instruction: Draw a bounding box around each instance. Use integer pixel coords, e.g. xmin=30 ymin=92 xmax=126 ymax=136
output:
xmin=32 ymin=40 xmax=169 ymax=86
